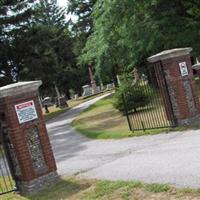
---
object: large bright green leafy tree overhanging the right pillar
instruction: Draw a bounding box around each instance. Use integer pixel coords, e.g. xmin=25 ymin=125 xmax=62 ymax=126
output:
xmin=80 ymin=0 xmax=200 ymax=81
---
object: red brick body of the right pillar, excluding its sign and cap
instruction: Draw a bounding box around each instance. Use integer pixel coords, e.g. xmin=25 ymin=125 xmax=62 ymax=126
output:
xmin=162 ymin=55 xmax=200 ymax=124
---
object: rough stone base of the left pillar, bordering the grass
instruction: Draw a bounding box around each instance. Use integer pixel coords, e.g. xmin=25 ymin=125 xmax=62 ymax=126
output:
xmin=18 ymin=171 xmax=59 ymax=195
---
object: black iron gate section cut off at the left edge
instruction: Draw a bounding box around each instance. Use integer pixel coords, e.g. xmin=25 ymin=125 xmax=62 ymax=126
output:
xmin=0 ymin=122 xmax=17 ymax=195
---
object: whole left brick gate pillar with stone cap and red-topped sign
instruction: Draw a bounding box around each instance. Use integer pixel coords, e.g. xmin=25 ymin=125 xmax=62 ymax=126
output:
xmin=0 ymin=81 xmax=58 ymax=194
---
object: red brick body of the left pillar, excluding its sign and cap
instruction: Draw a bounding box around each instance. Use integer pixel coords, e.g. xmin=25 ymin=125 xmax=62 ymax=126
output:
xmin=0 ymin=85 xmax=56 ymax=193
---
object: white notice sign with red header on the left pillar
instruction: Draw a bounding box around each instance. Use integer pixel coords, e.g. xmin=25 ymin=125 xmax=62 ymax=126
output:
xmin=15 ymin=100 xmax=38 ymax=124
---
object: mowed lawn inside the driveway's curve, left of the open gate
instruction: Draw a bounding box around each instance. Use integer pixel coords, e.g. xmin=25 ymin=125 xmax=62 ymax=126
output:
xmin=72 ymin=96 xmax=168 ymax=139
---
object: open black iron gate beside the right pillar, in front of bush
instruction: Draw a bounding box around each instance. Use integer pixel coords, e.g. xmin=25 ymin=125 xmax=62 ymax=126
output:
xmin=123 ymin=62 xmax=176 ymax=131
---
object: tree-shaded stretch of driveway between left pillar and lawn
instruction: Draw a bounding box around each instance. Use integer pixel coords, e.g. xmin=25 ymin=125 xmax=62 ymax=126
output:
xmin=47 ymin=93 xmax=112 ymax=162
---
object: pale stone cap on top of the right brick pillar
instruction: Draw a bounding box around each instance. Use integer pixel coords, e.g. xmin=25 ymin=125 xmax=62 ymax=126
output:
xmin=147 ymin=47 xmax=192 ymax=63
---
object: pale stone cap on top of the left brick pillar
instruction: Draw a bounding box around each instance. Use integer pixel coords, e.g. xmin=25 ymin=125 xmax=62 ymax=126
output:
xmin=0 ymin=81 xmax=42 ymax=98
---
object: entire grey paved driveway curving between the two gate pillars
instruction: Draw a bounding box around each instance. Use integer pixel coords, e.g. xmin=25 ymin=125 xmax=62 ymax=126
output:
xmin=47 ymin=94 xmax=200 ymax=188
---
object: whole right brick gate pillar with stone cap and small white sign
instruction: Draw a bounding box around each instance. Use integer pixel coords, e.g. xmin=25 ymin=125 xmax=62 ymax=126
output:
xmin=148 ymin=48 xmax=200 ymax=125
